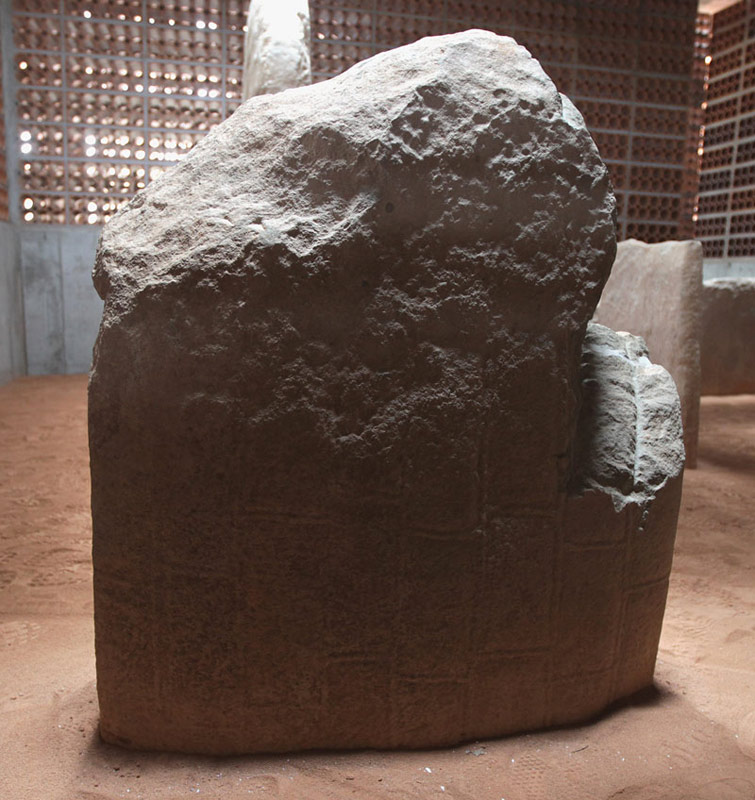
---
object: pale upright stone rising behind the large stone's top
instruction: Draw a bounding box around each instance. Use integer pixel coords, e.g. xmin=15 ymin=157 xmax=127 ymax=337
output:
xmin=241 ymin=0 xmax=312 ymax=100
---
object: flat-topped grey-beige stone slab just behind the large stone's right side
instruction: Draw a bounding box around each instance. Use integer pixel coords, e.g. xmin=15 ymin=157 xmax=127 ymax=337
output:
xmin=594 ymin=239 xmax=703 ymax=467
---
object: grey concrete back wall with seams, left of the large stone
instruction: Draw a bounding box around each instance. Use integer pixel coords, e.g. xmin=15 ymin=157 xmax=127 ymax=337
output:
xmin=18 ymin=225 xmax=102 ymax=375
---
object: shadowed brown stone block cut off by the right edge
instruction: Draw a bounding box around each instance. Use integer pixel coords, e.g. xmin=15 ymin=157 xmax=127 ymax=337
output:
xmin=700 ymin=278 xmax=755 ymax=394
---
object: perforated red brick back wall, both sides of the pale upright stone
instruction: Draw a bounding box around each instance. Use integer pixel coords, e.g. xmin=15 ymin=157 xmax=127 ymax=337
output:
xmin=7 ymin=0 xmax=702 ymax=236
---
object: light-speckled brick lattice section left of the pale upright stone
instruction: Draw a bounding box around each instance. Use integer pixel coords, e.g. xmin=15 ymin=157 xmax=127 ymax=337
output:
xmin=13 ymin=0 xmax=246 ymax=223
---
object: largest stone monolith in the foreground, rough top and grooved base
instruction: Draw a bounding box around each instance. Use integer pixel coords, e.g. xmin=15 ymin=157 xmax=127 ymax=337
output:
xmin=90 ymin=31 xmax=682 ymax=753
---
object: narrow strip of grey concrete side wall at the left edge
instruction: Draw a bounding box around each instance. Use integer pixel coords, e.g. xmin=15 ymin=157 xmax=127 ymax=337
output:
xmin=0 ymin=222 xmax=26 ymax=385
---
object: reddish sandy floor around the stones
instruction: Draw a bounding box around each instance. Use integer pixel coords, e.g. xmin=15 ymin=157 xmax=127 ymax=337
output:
xmin=0 ymin=376 xmax=755 ymax=800
